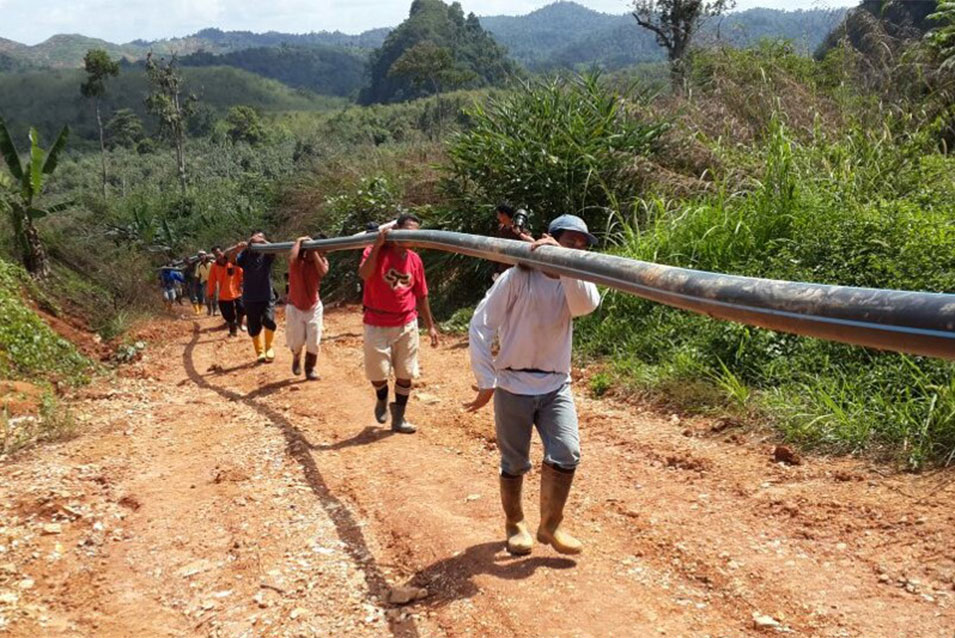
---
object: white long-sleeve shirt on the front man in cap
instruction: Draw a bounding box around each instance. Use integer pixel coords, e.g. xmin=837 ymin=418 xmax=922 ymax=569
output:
xmin=468 ymin=267 xmax=600 ymax=395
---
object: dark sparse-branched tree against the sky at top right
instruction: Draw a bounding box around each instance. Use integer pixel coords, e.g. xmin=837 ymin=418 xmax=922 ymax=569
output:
xmin=633 ymin=0 xmax=736 ymax=84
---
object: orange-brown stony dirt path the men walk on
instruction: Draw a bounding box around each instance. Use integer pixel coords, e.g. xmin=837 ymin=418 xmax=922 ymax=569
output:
xmin=0 ymin=310 xmax=955 ymax=638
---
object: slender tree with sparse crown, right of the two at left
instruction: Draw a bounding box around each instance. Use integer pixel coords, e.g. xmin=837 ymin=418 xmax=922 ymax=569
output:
xmin=146 ymin=51 xmax=196 ymax=195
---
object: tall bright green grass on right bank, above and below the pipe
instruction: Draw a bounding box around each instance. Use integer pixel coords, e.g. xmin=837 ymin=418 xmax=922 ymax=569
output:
xmin=578 ymin=113 xmax=955 ymax=468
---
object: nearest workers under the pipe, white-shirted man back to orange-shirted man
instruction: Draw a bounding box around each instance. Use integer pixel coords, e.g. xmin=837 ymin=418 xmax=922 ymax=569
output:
xmin=167 ymin=204 xmax=600 ymax=555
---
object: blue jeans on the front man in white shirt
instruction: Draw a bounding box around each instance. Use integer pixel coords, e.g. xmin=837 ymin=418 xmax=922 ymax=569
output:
xmin=494 ymin=383 xmax=580 ymax=476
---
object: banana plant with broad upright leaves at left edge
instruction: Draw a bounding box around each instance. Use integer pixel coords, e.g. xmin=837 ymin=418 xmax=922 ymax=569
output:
xmin=0 ymin=119 xmax=70 ymax=279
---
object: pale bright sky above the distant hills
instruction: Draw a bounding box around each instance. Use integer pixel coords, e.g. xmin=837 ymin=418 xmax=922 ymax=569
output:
xmin=0 ymin=0 xmax=857 ymax=44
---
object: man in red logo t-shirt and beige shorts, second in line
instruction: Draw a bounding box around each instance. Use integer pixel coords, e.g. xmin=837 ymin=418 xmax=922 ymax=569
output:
xmin=358 ymin=213 xmax=438 ymax=434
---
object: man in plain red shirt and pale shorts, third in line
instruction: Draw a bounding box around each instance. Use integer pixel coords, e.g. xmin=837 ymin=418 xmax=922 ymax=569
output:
xmin=285 ymin=237 xmax=328 ymax=381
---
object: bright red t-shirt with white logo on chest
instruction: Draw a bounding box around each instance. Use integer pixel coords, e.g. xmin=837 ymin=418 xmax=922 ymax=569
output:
xmin=361 ymin=244 xmax=428 ymax=326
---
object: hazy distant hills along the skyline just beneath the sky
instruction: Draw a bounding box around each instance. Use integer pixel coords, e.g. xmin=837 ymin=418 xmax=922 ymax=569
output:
xmin=0 ymin=2 xmax=845 ymax=72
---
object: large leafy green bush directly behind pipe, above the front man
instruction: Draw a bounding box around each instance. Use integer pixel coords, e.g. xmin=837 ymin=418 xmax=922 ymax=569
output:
xmin=442 ymin=73 xmax=667 ymax=238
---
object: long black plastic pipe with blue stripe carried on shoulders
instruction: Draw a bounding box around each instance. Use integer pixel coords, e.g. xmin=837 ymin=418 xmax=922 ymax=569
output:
xmin=251 ymin=230 xmax=955 ymax=359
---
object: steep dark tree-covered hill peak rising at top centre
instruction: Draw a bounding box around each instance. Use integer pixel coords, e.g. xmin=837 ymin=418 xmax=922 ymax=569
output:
xmin=359 ymin=0 xmax=516 ymax=104
